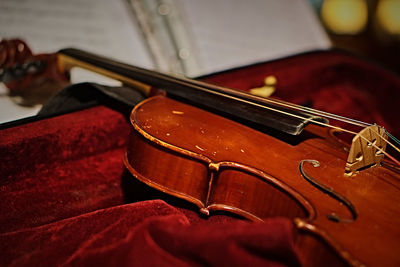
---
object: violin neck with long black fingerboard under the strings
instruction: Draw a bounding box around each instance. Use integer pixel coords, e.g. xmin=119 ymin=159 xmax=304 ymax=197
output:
xmin=58 ymin=48 xmax=327 ymax=135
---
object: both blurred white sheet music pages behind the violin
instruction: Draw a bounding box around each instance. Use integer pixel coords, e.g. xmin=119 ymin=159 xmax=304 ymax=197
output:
xmin=0 ymin=0 xmax=330 ymax=123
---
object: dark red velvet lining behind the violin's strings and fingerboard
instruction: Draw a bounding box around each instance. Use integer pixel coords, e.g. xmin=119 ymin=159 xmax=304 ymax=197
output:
xmin=208 ymin=52 xmax=400 ymax=136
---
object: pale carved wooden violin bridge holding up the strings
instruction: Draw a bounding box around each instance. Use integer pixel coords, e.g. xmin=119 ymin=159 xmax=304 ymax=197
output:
xmin=345 ymin=124 xmax=388 ymax=177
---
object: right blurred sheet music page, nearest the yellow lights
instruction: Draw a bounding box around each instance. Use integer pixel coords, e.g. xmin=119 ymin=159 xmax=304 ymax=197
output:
xmin=176 ymin=0 xmax=331 ymax=75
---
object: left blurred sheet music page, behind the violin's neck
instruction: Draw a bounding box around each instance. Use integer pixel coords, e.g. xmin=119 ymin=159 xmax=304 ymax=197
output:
xmin=0 ymin=0 xmax=154 ymax=123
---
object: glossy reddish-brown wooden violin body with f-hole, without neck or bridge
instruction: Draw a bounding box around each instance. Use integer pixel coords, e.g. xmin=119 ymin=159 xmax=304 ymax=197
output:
xmin=125 ymin=96 xmax=400 ymax=266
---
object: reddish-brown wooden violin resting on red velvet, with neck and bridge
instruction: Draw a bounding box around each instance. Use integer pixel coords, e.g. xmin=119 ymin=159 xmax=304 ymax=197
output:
xmin=2 ymin=38 xmax=400 ymax=266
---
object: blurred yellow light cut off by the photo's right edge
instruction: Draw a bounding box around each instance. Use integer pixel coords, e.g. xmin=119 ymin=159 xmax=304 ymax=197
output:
xmin=376 ymin=0 xmax=400 ymax=35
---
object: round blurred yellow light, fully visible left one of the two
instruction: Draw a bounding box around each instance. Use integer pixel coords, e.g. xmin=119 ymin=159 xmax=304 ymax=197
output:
xmin=321 ymin=0 xmax=368 ymax=34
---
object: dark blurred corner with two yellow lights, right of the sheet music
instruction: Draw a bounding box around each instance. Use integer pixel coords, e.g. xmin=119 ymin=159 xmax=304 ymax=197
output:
xmin=309 ymin=0 xmax=400 ymax=73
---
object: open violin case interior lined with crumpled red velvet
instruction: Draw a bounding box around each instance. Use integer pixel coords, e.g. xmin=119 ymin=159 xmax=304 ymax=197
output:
xmin=0 ymin=51 xmax=400 ymax=266
